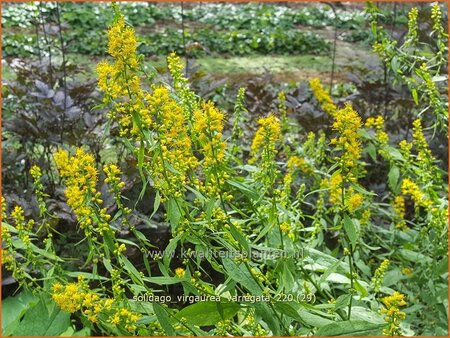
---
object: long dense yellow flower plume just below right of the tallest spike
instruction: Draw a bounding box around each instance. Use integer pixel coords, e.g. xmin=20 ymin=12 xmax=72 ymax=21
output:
xmin=146 ymin=87 xmax=198 ymax=197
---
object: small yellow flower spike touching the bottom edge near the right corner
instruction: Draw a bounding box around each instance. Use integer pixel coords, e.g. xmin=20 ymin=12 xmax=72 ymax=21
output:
xmin=381 ymin=291 xmax=406 ymax=336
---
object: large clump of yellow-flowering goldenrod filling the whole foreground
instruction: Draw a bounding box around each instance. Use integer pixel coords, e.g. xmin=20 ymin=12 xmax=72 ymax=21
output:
xmin=2 ymin=6 xmax=448 ymax=336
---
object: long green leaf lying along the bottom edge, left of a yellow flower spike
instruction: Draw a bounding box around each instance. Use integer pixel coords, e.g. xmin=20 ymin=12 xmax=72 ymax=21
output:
xmin=314 ymin=320 xmax=386 ymax=336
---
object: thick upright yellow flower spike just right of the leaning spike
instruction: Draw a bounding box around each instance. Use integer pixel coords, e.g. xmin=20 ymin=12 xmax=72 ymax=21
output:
xmin=331 ymin=104 xmax=362 ymax=171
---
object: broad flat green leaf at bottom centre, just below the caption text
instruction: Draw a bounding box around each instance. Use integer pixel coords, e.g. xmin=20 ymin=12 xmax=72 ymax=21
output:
xmin=175 ymin=301 xmax=241 ymax=326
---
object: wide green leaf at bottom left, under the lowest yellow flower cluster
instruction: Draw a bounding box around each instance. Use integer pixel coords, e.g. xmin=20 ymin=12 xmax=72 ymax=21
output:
xmin=13 ymin=298 xmax=71 ymax=336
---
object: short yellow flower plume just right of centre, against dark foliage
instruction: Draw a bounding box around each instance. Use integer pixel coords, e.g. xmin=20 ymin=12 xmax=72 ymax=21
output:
xmin=251 ymin=114 xmax=281 ymax=161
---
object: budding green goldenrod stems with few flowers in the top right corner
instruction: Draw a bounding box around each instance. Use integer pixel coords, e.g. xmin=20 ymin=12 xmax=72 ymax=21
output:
xmin=368 ymin=4 xmax=448 ymax=132
